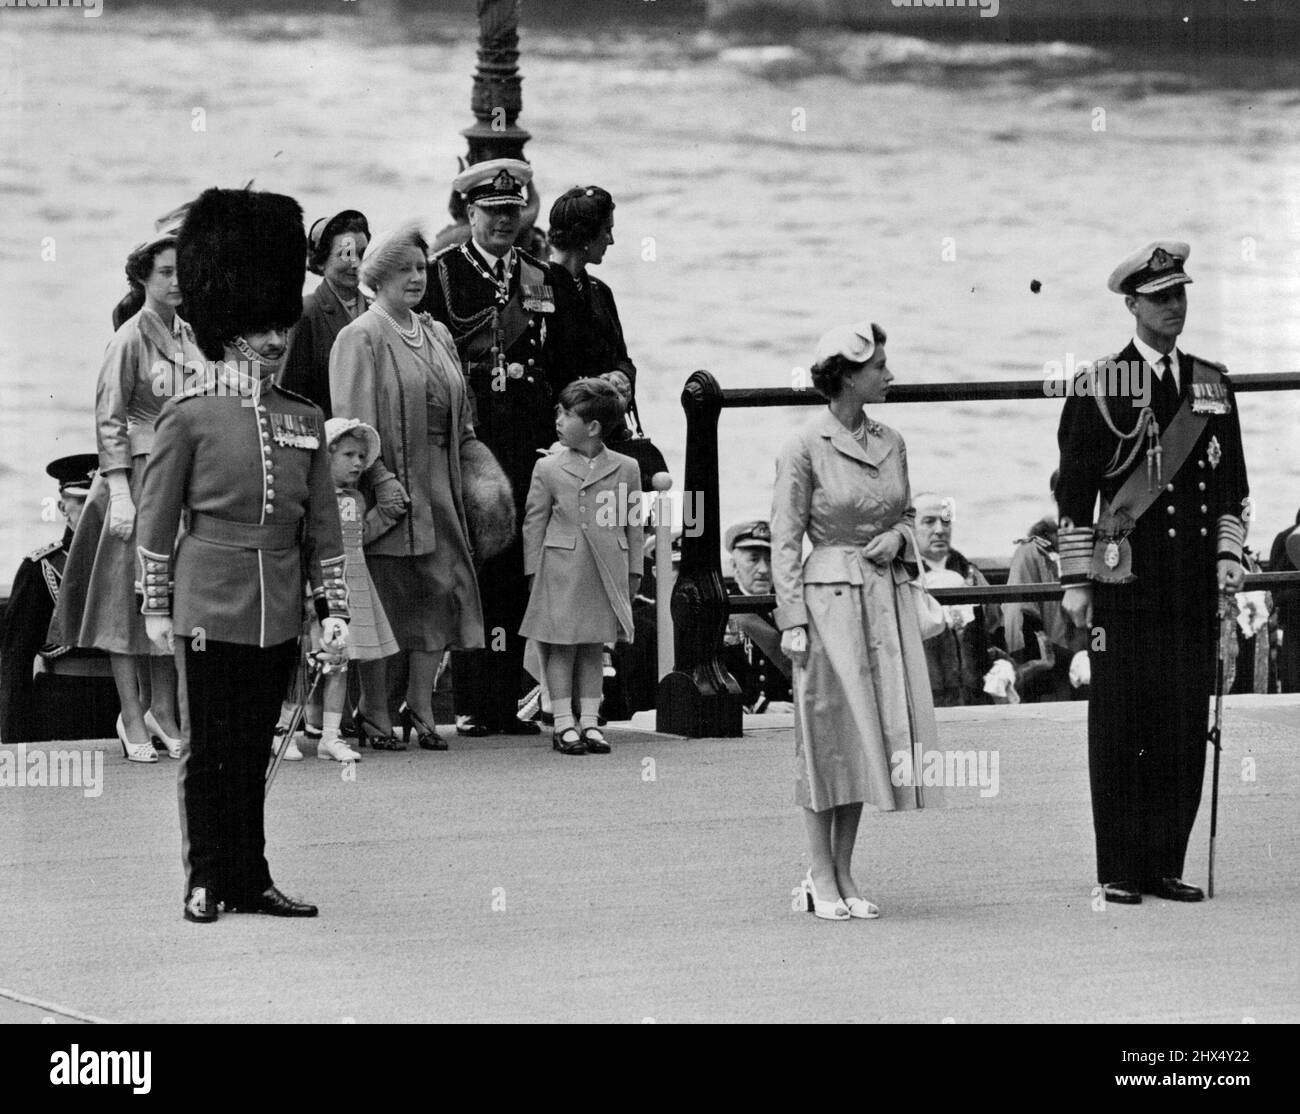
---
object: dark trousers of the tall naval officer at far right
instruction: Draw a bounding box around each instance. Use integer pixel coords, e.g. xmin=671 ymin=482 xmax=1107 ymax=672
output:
xmin=1088 ymin=585 xmax=1216 ymax=884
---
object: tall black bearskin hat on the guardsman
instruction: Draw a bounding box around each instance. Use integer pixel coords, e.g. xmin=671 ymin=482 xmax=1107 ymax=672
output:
xmin=176 ymin=190 xmax=307 ymax=360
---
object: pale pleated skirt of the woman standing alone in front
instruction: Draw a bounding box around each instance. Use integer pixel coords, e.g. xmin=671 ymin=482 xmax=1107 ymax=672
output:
xmin=794 ymin=560 xmax=943 ymax=812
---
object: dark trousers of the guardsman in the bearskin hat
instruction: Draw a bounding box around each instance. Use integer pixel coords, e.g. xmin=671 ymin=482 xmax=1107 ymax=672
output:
xmin=179 ymin=640 xmax=298 ymax=901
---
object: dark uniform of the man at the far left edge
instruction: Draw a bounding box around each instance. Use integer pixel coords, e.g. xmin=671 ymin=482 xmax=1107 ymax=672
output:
xmin=0 ymin=529 xmax=117 ymax=742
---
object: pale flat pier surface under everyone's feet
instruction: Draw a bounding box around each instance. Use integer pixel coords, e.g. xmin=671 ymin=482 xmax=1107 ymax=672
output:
xmin=0 ymin=697 xmax=1300 ymax=1024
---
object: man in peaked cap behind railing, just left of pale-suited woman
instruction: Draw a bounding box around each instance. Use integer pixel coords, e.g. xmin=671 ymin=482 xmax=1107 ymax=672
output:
xmin=723 ymin=519 xmax=794 ymax=712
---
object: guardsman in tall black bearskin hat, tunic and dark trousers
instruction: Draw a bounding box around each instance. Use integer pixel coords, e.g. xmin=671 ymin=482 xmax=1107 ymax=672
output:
xmin=138 ymin=190 xmax=347 ymax=922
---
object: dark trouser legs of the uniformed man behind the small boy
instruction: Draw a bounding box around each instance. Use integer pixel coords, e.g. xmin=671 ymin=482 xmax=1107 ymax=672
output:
xmin=451 ymin=539 xmax=528 ymax=729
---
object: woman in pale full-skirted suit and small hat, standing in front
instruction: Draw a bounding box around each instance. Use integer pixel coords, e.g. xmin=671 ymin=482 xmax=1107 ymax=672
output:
xmin=772 ymin=322 xmax=937 ymax=920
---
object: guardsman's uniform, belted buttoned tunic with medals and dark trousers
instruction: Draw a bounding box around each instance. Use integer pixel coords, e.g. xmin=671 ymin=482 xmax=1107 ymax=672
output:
xmin=138 ymin=367 xmax=347 ymax=905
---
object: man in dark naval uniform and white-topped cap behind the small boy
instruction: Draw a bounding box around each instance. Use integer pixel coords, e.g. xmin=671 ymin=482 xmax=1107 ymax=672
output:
xmin=416 ymin=159 xmax=555 ymax=736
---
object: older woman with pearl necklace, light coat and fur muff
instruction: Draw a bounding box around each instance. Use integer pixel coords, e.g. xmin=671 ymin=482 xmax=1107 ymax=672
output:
xmin=329 ymin=222 xmax=515 ymax=750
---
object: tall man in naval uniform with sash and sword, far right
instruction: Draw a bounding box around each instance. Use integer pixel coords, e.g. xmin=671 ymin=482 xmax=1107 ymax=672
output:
xmin=1057 ymin=240 xmax=1249 ymax=905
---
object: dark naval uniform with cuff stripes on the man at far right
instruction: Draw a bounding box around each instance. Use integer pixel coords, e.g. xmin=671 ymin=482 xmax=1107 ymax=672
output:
xmin=1057 ymin=343 xmax=1248 ymax=900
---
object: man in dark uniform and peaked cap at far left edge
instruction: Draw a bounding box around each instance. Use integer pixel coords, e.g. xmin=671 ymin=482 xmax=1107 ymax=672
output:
xmin=0 ymin=452 xmax=108 ymax=742
